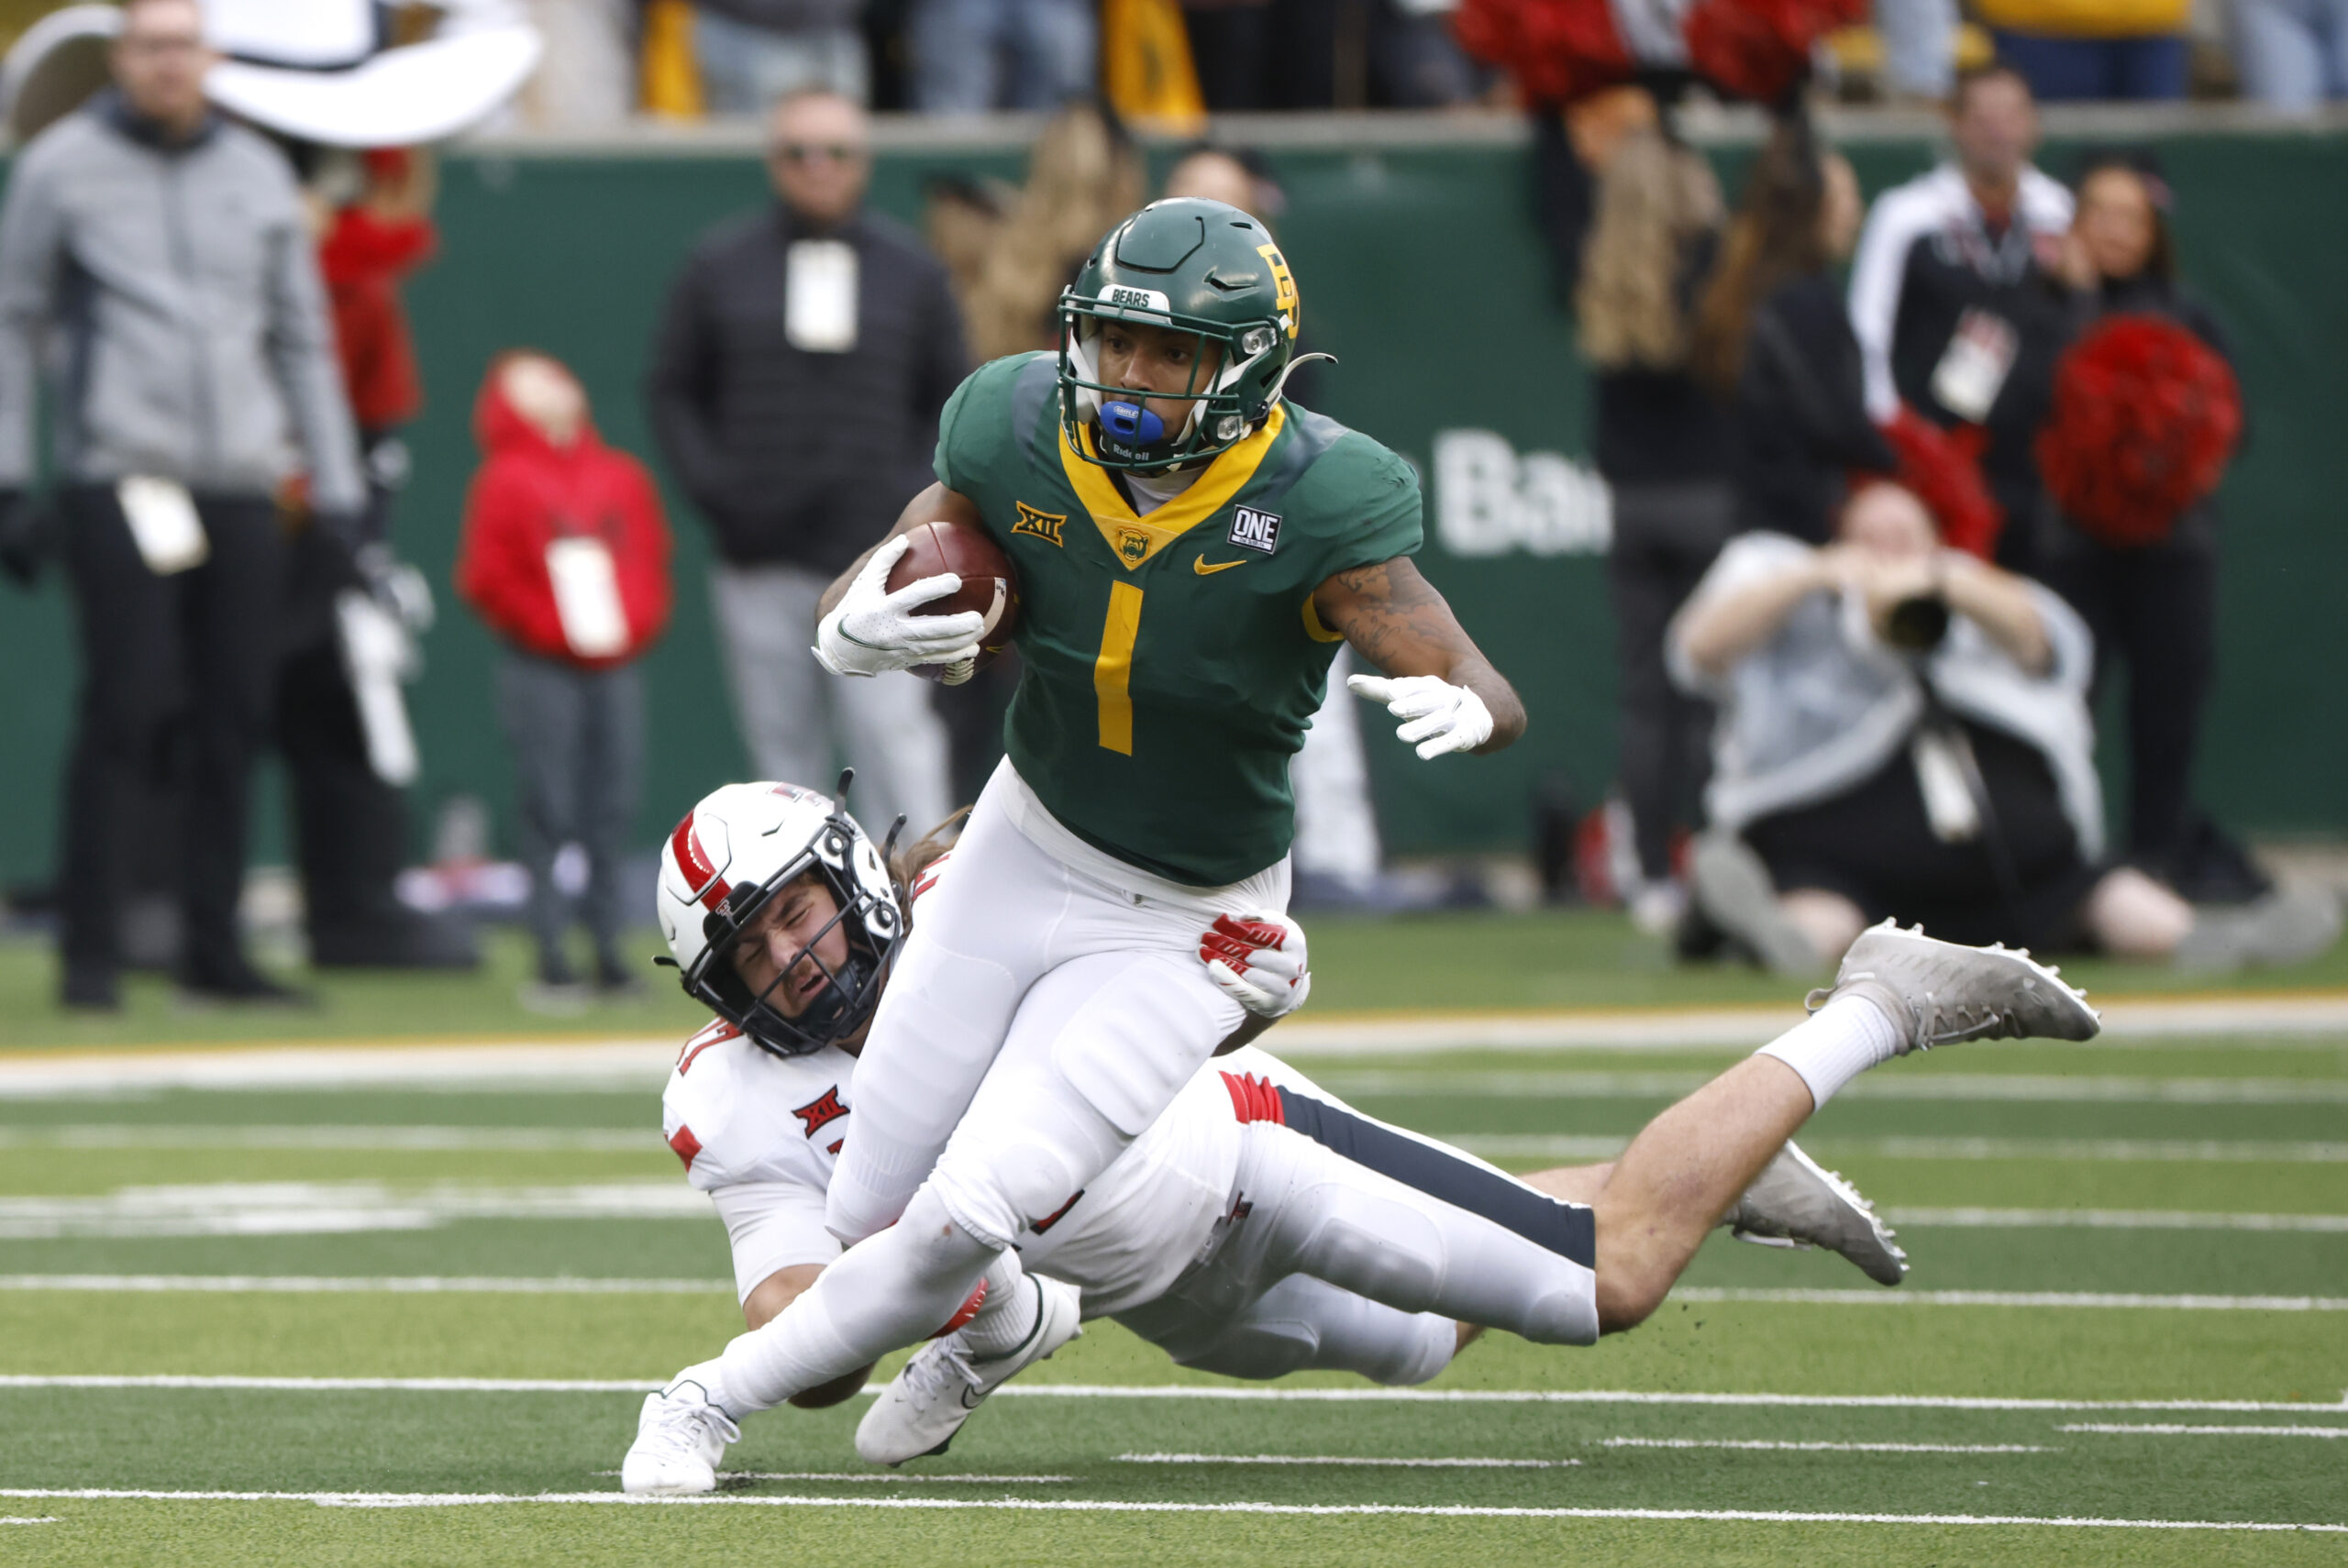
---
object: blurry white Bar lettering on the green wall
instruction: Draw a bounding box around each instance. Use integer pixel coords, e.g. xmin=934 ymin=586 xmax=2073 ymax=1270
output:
xmin=1434 ymin=429 xmax=1613 ymax=557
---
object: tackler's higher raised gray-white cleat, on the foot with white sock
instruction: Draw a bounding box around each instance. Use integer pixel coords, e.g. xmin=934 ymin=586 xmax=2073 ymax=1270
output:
xmin=1811 ymin=920 xmax=2104 ymax=1056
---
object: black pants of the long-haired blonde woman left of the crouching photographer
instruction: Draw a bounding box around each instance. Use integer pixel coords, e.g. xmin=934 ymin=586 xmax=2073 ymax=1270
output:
xmin=1606 ymin=483 xmax=1735 ymax=883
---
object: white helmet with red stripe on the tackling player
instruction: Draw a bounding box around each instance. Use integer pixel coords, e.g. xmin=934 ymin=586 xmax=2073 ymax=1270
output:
xmin=658 ymin=772 xmax=904 ymax=1056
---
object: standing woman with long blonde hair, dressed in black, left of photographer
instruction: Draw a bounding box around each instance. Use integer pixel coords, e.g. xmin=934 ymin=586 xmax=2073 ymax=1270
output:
xmin=1538 ymin=87 xmax=1731 ymax=932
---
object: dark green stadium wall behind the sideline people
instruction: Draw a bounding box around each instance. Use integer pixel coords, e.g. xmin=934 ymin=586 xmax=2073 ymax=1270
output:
xmin=0 ymin=120 xmax=2348 ymax=883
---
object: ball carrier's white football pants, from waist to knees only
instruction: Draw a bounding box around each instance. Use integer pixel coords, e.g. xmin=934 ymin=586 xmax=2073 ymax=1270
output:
xmin=826 ymin=760 xmax=1289 ymax=1246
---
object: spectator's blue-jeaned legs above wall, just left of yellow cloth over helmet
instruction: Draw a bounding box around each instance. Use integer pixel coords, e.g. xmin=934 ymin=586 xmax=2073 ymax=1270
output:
xmin=906 ymin=0 xmax=1099 ymax=115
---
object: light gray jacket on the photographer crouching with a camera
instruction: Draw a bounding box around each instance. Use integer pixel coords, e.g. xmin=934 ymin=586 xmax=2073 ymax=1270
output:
xmin=1662 ymin=533 xmax=2104 ymax=859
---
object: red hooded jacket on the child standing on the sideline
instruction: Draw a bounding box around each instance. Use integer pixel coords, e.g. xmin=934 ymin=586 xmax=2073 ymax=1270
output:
xmin=456 ymin=359 xmax=674 ymax=669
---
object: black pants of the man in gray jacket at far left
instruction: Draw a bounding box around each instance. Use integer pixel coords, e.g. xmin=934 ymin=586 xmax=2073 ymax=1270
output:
xmin=56 ymin=486 xmax=286 ymax=1002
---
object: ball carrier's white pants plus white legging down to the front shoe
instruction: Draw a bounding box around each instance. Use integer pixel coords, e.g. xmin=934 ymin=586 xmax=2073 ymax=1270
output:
xmin=704 ymin=763 xmax=1287 ymax=1413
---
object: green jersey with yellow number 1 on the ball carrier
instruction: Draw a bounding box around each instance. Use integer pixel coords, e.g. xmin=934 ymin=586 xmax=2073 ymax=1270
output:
xmin=936 ymin=355 xmax=1421 ymax=888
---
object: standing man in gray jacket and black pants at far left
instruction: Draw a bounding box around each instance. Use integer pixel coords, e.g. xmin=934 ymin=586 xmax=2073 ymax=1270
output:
xmin=0 ymin=0 xmax=364 ymax=1007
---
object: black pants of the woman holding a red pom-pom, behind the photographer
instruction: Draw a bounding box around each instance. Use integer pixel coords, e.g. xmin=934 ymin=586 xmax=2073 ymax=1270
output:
xmin=2043 ymin=509 xmax=2264 ymax=901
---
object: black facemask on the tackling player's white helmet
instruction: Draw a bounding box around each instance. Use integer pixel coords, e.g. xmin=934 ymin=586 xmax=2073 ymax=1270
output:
xmin=681 ymin=817 xmax=904 ymax=1056
